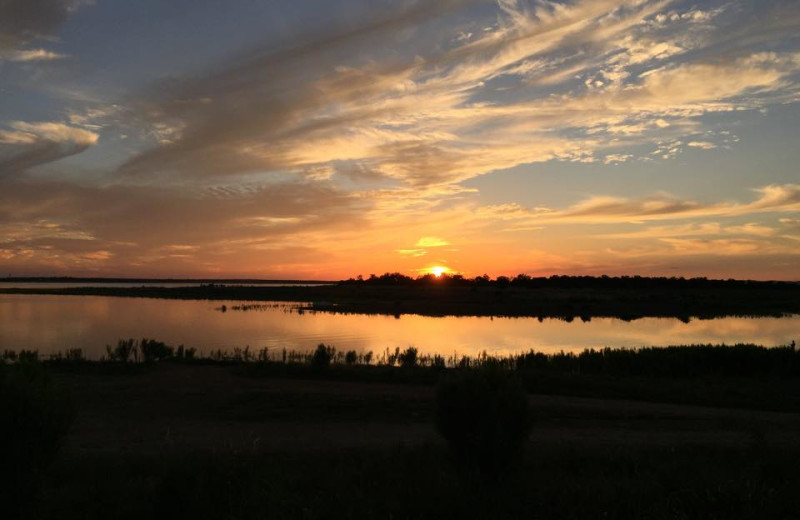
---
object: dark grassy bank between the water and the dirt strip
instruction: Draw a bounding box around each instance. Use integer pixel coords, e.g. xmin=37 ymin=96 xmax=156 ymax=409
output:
xmin=14 ymin=339 xmax=800 ymax=411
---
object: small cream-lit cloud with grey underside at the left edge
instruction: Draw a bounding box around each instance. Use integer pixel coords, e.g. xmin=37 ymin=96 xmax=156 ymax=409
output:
xmin=0 ymin=121 xmax=100 ymax=179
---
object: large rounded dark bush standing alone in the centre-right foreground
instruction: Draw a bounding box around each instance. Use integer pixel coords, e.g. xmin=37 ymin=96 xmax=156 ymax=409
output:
xmin=436 ymin=366 xmax=531 ymax=477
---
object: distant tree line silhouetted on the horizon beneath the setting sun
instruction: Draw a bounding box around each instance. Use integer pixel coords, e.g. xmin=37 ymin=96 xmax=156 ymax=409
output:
xmin=339 ymin=273 xmax=800 ymax=289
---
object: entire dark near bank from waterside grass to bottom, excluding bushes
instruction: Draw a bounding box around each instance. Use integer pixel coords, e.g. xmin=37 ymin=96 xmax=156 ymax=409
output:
xmin=0 ymin=348 xmax=800 ymax=519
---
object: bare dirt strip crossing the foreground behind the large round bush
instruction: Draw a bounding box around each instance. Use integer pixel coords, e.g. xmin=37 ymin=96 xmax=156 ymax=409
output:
xmin=55 ymin=364 xmax=800 ymax=454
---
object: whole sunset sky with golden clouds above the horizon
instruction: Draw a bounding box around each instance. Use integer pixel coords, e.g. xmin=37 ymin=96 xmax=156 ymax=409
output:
xmin=0 ymin=0 xmax=800 ymax=280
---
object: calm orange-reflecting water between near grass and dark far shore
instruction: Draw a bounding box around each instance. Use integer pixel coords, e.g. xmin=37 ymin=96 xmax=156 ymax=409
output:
xmin=0 ymin=294 xmax=800 ymax=357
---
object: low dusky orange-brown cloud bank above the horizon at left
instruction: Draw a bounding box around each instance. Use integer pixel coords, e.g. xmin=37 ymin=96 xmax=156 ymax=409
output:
xmin=0 ymin=177 xmax=369 ymax=274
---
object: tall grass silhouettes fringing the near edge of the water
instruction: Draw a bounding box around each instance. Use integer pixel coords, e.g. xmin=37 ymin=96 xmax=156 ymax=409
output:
xmin=14 ymin=338 xmax=800 ymax=379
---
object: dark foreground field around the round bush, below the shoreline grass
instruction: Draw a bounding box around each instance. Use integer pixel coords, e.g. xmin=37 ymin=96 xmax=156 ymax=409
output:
xmin=6 ymin=363 xmax=800 ymax=519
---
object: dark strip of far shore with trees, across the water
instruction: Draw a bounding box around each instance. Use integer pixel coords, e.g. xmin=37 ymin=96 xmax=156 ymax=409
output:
xmin=7 ymin=273 xmax=800 ymax=321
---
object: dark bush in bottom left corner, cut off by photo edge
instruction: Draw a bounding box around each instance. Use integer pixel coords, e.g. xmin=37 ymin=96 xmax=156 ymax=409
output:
xmin=0 ymin=361 xmax=73 ymax=519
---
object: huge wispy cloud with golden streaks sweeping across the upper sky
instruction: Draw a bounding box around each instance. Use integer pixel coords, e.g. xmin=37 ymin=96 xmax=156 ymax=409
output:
xmin=108 ymin=0 xmax=800 ymax=187
